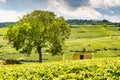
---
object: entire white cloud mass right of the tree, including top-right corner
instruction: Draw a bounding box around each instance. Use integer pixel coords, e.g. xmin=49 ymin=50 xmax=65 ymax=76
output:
xmin=48 ymin=0 xmax=120 ymax=22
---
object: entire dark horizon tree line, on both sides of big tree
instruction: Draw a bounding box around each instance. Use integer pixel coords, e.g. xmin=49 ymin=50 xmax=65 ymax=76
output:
xmin=0 ymin=19 xmax=120 ymax=27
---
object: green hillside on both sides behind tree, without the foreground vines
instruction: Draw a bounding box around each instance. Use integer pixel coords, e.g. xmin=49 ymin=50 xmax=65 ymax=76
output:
xmin=0 ymin=25 xmax=120 ymax=61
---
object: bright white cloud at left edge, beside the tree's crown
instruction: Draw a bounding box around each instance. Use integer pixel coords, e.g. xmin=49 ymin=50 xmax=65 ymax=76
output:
xmin=0 ymin=10 xmax=24 ymax=22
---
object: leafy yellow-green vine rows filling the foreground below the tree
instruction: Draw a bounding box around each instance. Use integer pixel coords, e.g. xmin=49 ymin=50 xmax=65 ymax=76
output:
xmin=0 ymin=57 xmax=120 ymax=80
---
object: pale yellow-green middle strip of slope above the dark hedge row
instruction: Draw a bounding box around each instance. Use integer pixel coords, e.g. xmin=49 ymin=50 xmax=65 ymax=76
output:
xmin=66 ymin=36 xmax=120 ymax=49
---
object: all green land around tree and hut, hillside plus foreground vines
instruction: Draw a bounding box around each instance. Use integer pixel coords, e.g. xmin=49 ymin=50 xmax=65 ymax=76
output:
xmin=0 ymin=25 xmax=120 ymax=80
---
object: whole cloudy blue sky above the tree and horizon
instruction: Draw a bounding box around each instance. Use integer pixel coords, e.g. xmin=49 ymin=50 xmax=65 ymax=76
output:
xmin=0 ymin=0 xmax=120 ymax=22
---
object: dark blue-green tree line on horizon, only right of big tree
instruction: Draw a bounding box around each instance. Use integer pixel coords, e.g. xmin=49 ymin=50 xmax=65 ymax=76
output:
xmin=67 ymin=19 xmax=114 ymax=25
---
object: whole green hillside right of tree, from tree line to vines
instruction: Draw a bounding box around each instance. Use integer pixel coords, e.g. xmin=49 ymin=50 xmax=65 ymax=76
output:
xmin=66 ymin=25 xmax=120 ymax=58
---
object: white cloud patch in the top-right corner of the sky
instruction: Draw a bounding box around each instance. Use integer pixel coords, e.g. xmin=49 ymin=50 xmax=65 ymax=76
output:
xmin=90 ymin=0 xmax=120 ymax=8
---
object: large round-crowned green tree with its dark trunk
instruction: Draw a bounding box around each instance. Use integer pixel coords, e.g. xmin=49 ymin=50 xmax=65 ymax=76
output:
xmin=5 ymin=10 xmax=70 ymax=62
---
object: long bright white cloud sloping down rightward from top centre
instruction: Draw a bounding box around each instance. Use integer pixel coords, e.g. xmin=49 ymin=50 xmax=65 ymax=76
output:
xmin=49 ymin=0 xmax=102 ymax=19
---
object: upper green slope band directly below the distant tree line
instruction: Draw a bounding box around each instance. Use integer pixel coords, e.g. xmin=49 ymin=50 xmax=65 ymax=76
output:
xmin=70 ymin=25 xmax=120 ymax=39
